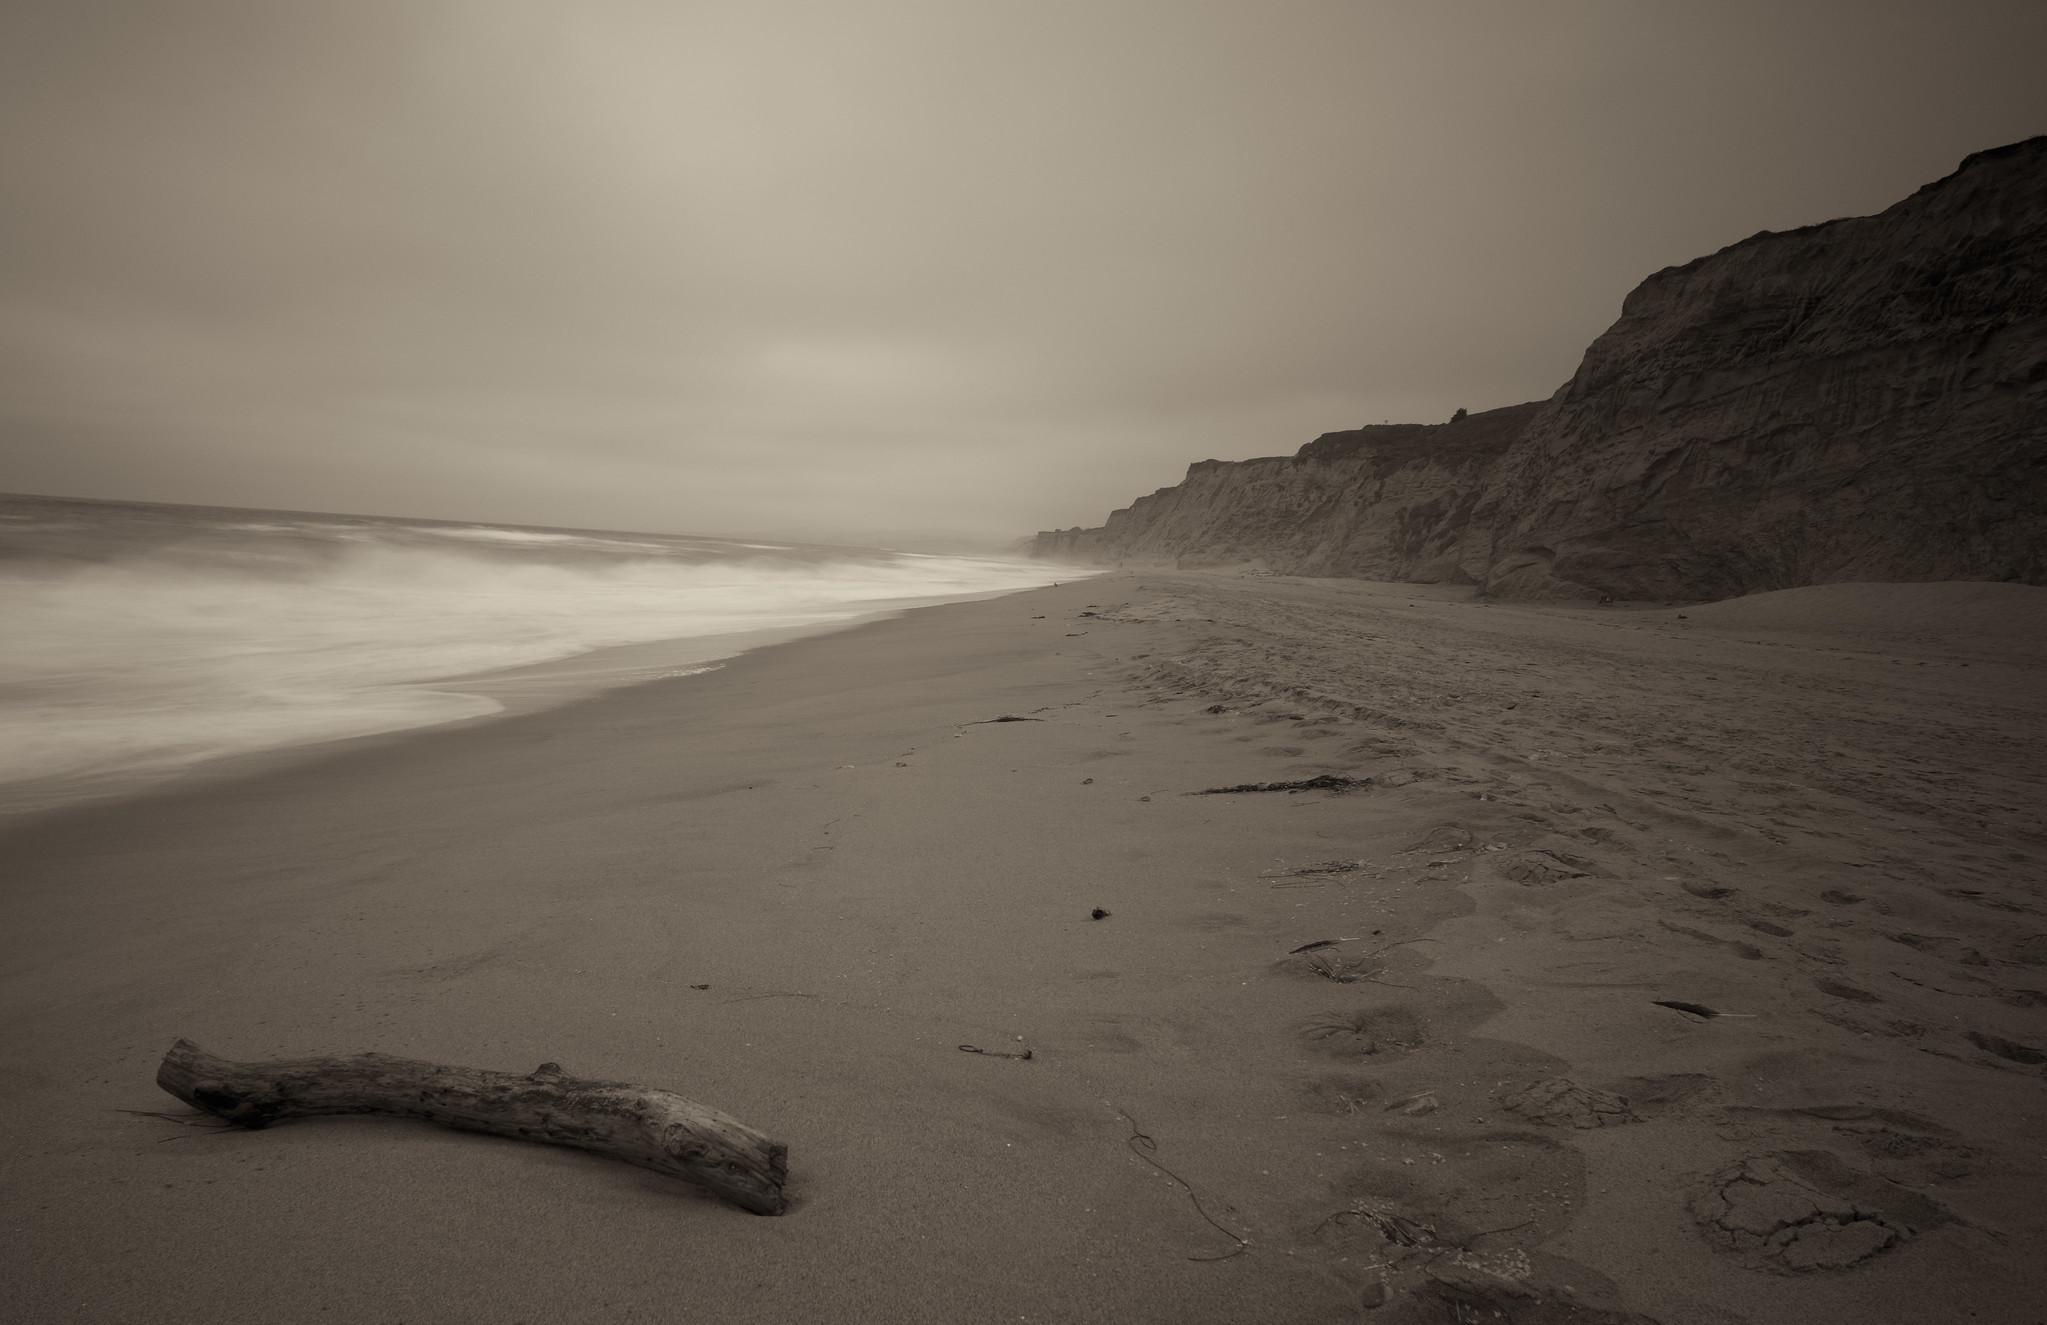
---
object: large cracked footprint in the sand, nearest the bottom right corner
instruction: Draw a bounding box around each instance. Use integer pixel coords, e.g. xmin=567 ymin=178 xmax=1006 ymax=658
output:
xmin=1691 ymin=1151 xmax=1955 ymax=1274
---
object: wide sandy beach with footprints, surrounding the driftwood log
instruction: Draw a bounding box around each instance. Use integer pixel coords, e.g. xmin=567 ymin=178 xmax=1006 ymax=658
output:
xmin=0 ymin=575 xmax=2047 ymax=1325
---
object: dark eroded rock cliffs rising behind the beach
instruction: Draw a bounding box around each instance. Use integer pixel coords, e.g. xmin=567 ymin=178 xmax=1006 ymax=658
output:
xmin=1030 ymin=137 xmax=2047 ymax=600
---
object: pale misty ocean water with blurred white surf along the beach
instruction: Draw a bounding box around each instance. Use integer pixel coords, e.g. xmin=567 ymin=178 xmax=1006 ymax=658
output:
xmin=0 ymin=496 xmax=1071 ymax=811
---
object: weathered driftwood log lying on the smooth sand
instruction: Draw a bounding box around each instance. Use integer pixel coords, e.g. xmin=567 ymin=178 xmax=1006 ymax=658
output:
xmin=156 ymin=1040 xmax=788 ymax=1214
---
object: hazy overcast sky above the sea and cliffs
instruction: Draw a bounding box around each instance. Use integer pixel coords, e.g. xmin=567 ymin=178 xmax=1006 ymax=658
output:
xmin=0 ymin=0 xmax=2047 ymax=545
